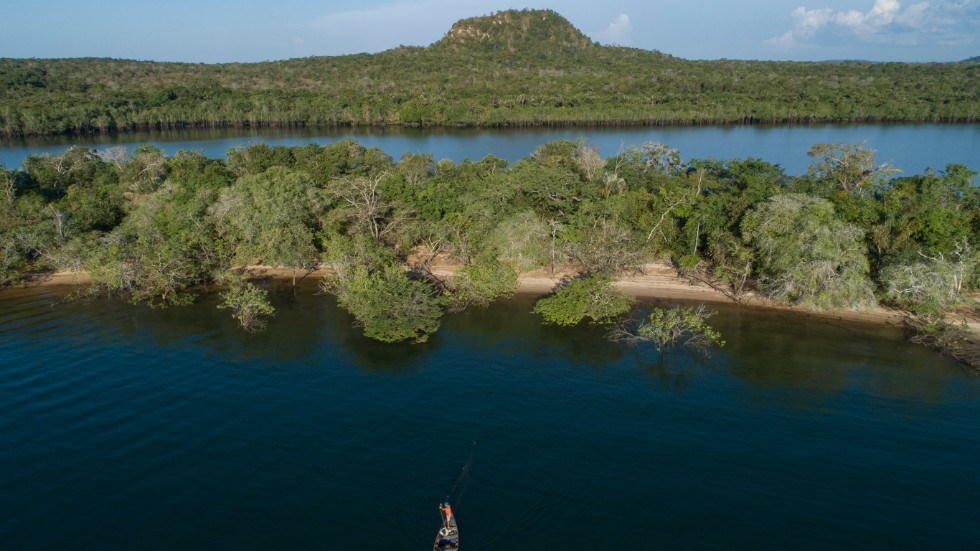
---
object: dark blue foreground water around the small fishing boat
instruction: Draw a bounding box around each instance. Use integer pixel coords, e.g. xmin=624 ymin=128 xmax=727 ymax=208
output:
xmin=0 ymin=287 xmax=980 ymax=549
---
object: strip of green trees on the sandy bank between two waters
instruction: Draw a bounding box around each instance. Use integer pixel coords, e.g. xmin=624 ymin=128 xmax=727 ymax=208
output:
xmin=0 ymin=140 xmax=980 ymax=359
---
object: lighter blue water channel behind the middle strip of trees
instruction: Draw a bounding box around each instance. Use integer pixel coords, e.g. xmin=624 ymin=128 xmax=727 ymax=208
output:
xmin=0 ymin=124 xmax=980 ymax=175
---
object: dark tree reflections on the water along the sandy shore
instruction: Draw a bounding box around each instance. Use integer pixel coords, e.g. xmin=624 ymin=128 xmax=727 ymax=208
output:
xmin=3 ymin=280 xmax=972 ymax=403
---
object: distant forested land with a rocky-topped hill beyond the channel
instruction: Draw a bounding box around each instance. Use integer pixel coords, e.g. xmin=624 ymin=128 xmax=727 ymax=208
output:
xmin=0 ymin=10 xmax=980 ymax=137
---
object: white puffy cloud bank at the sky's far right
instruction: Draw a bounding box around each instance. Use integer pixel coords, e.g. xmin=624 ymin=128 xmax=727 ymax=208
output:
xmin=766 ymin=0 xmax=980 ymax=48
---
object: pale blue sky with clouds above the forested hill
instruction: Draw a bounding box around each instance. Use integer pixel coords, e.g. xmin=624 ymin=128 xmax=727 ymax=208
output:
xmin=0 ymin=0 xmax=980 ymax=63
